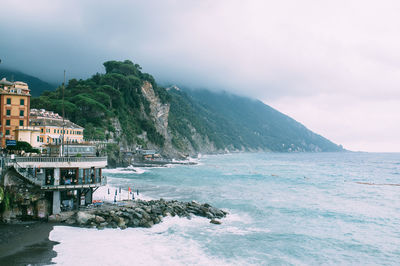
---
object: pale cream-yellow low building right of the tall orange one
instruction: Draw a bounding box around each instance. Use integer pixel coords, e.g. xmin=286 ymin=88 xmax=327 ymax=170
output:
xmin=30 ymin=109 xmax=84 ymax=145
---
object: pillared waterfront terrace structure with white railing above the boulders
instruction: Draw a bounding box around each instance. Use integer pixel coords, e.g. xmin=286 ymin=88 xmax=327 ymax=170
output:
xmin=5 ymin=156 xmax=107 ymax=214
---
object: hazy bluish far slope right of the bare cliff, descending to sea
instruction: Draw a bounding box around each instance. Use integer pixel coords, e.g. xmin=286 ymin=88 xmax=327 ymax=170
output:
xmin=170 ymin=89 xmax=343 ymax=152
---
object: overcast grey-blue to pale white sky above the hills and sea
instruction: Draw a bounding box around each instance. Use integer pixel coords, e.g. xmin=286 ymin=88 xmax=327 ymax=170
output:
xmin=0 ymin=0 xmax=400 ymax=152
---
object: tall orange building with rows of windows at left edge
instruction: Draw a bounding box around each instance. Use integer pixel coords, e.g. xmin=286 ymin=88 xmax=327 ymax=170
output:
xmin=0 ymin=78 xmax=31 ymax=148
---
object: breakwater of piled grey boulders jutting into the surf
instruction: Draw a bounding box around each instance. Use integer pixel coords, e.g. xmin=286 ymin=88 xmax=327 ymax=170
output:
xmin=49 ymin=199 xmax=228 ymax=229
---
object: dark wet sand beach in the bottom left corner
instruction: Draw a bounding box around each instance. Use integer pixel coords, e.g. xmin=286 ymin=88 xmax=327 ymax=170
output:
xmin=0 ymin=222 xmax=58 ymax=265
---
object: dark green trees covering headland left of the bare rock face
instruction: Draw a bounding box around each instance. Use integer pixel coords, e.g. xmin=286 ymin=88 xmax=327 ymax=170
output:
xmin=31 ymin=60 xmax=169 ymax=146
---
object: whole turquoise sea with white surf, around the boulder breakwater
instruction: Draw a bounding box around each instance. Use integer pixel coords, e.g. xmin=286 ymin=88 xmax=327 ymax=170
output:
xmin=50 ymin=152 xmax=400 ymax=265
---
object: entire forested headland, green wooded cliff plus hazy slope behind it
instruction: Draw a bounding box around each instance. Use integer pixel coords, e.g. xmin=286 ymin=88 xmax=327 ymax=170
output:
xmin=26 ymin=60 xmax=342 ymax=157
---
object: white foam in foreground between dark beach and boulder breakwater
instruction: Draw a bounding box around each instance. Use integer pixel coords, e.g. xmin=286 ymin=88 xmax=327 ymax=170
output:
xmin=49 ymin=217 xmax=240 ymax=265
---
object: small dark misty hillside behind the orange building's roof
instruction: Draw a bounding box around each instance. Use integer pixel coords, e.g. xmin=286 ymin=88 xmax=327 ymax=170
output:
xmin=0 ymin=68 xmax=56 ymax=96
